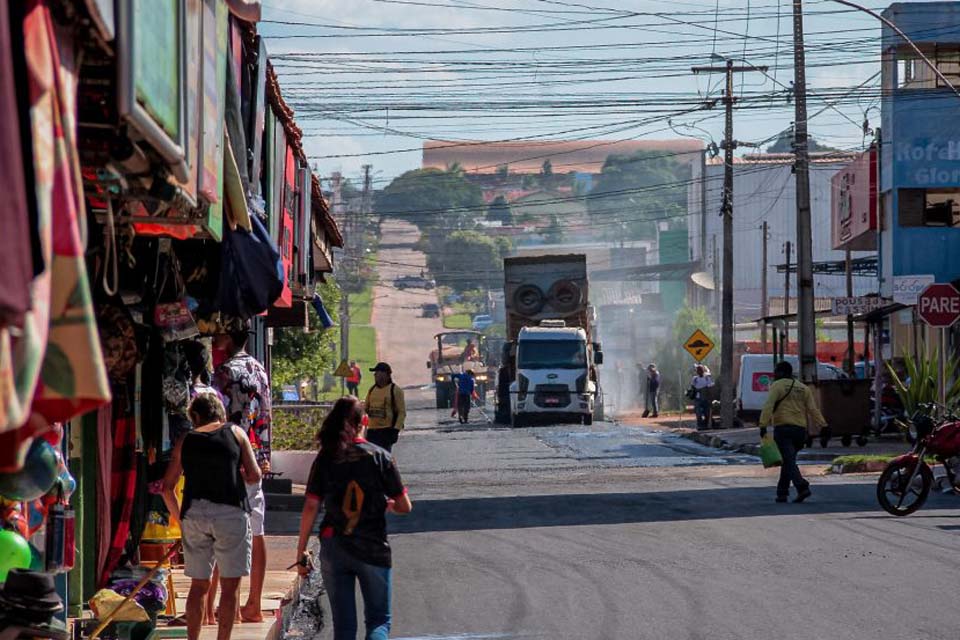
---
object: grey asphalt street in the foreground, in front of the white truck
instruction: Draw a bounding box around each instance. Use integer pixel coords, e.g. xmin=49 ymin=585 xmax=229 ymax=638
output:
xmin=271 ymin=392 xmax=960 ymax=640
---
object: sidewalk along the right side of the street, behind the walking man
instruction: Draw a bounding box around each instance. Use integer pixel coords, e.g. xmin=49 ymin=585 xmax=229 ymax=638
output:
xmin=619 ymin=411 xmax=910 ymax=462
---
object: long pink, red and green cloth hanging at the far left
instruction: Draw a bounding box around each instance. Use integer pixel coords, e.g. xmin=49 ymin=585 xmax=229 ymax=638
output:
xmin=0 ymin=0 xmax=110 ymax=467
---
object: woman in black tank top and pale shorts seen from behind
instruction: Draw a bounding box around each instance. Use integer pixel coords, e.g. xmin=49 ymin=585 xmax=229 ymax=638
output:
xmin=163 ymin=392 xmax=260 ymax=640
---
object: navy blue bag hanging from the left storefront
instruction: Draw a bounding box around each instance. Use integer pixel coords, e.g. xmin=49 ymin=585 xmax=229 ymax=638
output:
xmin=217 ymin=216 xmax=284 ymax=320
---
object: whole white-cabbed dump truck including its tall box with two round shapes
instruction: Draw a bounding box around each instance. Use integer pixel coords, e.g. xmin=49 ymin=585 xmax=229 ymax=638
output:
xmin=496 ymin=254 xmax=603 ymax=427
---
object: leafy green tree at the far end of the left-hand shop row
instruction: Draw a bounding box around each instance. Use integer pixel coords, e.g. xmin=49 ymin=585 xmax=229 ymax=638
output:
xmin=270 ymin=281 xmax=340 ymax=395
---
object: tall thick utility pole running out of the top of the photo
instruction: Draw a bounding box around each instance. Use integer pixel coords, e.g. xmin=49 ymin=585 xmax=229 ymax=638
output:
xmin=793 ymin=0 xmax=817 ymax=383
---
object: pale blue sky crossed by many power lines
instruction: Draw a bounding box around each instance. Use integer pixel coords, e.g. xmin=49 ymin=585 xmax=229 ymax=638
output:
xmin=259 ymin=0 xmax=900 ymax=188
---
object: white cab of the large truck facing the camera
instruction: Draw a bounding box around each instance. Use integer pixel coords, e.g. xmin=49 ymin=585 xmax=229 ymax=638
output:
xmin=510 ymin=320 xmax=602 ymax=427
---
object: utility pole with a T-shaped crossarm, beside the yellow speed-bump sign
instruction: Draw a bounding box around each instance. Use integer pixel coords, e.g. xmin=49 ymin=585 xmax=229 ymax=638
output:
xmin=692 ymin=60 xmax=767 ymax=429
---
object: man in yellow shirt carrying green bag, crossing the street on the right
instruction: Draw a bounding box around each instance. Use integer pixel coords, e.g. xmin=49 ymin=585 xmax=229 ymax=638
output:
xmin=760 ymin=362 xmax=827 ymax=502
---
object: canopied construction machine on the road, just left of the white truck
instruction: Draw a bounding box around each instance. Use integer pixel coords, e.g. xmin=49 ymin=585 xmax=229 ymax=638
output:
xmin=427 ymin=329 xmax=492 ymax=409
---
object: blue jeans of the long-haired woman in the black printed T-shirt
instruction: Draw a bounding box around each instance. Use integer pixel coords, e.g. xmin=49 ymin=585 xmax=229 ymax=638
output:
xmin=320 ymin=537 xmax=391 ymax=640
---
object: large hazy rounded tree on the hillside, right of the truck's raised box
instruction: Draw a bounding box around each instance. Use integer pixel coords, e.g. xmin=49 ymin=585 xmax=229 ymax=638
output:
xmin=587 ymin=151 xmax=691 ymax=240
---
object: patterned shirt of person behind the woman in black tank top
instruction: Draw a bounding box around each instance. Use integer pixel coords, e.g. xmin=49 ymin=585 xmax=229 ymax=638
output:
xmin=213 ymin=351 xmax=271 ymax=463
